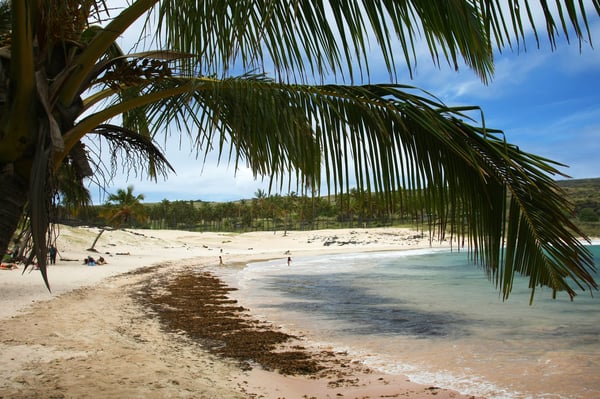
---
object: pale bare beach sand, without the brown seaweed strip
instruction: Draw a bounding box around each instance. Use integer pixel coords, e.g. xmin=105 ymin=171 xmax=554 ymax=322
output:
xmin=0 ymin=226 xmax=488 ymax=399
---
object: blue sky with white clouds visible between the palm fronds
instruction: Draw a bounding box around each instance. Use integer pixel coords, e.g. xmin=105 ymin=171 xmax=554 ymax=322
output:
xmin=89 ymin=5 xmax=600 ymax=204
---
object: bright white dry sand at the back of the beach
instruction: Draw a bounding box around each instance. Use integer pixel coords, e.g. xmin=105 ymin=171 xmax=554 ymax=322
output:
xmin=0 ymin=226 xmax=450 ymax=319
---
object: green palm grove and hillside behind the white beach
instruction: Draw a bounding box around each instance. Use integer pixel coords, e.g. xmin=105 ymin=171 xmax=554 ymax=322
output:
xmin=68 ymin=178 xmax=600 ymax=237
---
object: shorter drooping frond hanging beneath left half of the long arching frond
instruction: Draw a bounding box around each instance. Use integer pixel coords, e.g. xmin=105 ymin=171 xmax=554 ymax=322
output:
xmin=123 ymin=74 xmax=320 ymax=194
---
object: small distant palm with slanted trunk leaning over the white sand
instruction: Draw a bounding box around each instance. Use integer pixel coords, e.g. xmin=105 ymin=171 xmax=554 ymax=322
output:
xmin=88 ymin=186 xmax=146 ymax=251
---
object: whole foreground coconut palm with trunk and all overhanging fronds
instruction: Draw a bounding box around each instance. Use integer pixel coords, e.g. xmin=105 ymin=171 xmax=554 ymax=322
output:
xmin=0 ymin=0 xmax=600 ymax=296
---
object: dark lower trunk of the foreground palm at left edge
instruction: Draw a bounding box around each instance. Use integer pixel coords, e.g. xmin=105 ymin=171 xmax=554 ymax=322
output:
xmin=0 ymin=168 xmax=28 ymax=254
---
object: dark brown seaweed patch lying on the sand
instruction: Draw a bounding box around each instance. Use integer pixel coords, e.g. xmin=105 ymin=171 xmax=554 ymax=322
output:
xmin=138 ymin=272 xmax=331 ymax=375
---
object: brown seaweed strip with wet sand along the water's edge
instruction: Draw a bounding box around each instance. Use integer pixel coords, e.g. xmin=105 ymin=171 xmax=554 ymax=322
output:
xmin=138 ymin=266 xmax=486 ymax=399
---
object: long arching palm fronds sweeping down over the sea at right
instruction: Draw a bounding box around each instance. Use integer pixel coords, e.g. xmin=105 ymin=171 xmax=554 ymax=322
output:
xmin=131 ymin=75 xmax=597 ymax=298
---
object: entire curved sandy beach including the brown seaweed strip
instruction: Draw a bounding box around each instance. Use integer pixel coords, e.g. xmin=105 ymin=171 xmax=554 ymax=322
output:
xmin=0 ymin=226 xmax=486 ymax=399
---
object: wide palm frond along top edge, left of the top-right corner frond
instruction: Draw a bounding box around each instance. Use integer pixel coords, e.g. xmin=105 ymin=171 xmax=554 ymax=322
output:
xmin=151 ymin=0 xmax=492 ymax=79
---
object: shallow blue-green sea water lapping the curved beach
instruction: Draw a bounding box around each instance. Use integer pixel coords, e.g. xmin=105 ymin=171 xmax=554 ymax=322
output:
xmin=226 ymin=245 xmax=600 ymax=399
